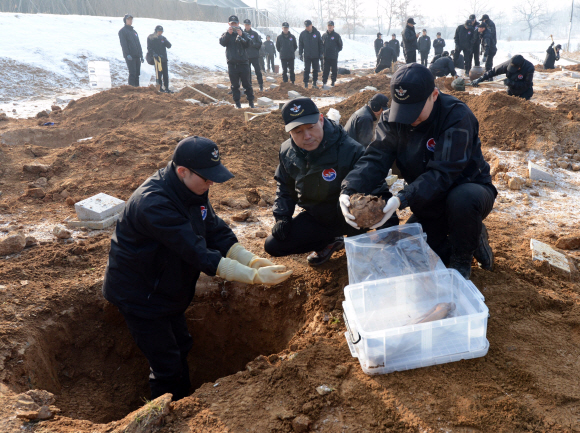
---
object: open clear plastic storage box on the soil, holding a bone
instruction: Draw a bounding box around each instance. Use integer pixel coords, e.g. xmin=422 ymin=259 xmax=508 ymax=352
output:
xmin=343 ymin=269 xmax=489 ymax=374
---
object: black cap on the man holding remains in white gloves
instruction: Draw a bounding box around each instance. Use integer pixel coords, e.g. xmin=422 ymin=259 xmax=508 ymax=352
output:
xmin=389 ymin=63 xmax=435 ymax=125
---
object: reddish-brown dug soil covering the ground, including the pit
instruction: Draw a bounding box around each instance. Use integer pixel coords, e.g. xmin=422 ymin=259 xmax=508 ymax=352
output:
xmin=0 ymin=75 xmax=580 ymax=433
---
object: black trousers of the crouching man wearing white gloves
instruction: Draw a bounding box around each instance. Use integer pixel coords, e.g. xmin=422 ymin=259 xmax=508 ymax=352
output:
xmin=407 ymin=183 xmax=497 ymax=265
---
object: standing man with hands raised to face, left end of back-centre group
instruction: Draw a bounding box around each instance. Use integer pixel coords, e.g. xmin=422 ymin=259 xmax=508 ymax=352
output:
xmin=220 ymin=15 xmax=254 ymax=108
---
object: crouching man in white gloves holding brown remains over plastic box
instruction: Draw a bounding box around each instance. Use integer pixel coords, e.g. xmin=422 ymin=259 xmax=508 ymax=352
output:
xmin=340 ymin=64 xmax=497 ymax=278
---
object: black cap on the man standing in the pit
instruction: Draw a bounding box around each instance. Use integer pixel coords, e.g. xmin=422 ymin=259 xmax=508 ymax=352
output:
xmin=172 ymin=135 xmax=234 ymax=183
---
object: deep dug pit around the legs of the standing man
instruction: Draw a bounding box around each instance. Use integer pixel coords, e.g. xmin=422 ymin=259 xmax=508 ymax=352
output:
xmin=19 ymin=277 xmax=305 ymax=423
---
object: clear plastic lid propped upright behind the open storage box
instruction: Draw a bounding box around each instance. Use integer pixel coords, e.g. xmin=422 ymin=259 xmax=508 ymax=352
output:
xmin=344 ymin=224 xmax=445 ymax=284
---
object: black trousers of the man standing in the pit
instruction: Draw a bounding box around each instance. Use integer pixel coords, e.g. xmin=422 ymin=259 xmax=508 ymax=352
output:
xmin=121 ymin=311 xmax=193 ymax=400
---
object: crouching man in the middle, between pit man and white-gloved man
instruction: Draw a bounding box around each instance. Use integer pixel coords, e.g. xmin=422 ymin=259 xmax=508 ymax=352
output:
xmin=264 ymin=98 xmax=398 ymax=266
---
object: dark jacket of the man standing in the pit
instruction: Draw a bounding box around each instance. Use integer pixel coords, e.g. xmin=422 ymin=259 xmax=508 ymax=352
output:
xmin=103 ymin=162 xmax=237 ymax=319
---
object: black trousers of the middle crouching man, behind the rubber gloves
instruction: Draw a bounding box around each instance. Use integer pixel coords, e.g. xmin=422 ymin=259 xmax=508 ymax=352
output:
xmin=264 ymin=211 xmax=399 ymax=257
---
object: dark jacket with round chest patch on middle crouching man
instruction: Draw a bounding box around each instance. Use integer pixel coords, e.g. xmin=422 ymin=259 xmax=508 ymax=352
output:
xmin=273 ymin=119 xmax=370 ymax=225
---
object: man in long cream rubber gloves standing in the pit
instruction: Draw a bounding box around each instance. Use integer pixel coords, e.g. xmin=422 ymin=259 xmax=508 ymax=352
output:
xmin=103 ymin=137 xmax=292 ymax=400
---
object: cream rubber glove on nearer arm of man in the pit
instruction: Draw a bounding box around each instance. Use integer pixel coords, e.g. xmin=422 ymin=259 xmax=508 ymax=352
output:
xmin=216 ymin=257 xmax=292 ymax=286
